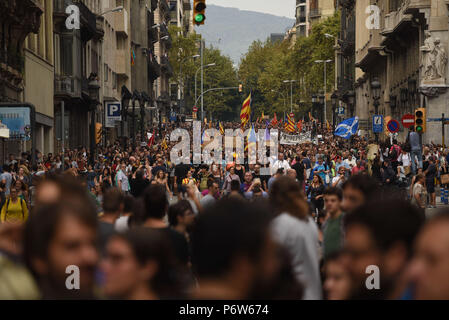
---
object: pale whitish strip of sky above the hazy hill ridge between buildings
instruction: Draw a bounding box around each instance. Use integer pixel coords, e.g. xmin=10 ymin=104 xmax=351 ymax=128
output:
xmin=207 ymin=0 xmax=296 ymax=19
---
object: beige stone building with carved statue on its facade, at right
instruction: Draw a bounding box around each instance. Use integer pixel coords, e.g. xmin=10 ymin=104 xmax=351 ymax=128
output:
xmin=354 ymin=0 xmax=449 ymax=144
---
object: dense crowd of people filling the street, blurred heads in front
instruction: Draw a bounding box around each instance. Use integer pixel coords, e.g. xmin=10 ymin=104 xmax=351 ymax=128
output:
xmin=0 ymin=123 xmax=449 ymax=300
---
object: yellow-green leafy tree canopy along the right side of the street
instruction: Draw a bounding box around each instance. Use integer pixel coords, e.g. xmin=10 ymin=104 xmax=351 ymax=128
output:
xmin=239 ymin=13 xmax=340 ymax=120
